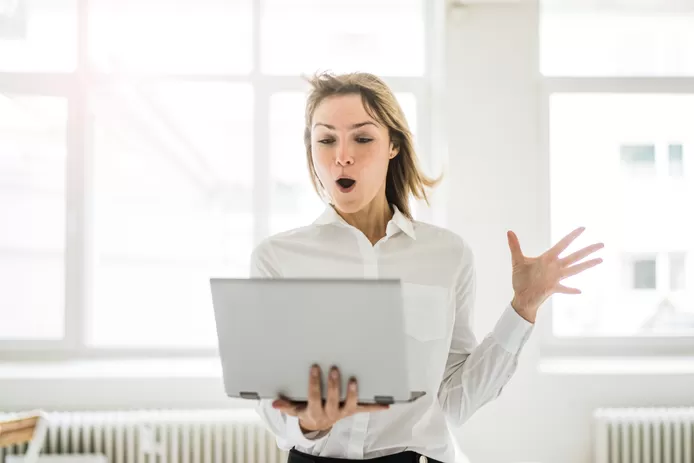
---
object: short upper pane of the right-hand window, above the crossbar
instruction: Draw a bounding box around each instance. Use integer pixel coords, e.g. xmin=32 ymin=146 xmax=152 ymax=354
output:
xmin=540 ymin=0 xmax=694 ymax=76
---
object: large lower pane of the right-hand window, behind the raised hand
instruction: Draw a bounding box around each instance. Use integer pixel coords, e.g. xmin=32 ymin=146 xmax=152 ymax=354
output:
xmin=550 ymin=94 xmax=694 ymax=336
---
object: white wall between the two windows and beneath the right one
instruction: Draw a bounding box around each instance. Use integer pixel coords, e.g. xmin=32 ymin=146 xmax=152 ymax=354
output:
xmin=447 ymin=2 xmax=694 ymax=463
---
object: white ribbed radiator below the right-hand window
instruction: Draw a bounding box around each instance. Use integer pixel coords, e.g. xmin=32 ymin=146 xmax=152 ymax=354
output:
xmin=594 ymin=408 xmax=694 ymax=463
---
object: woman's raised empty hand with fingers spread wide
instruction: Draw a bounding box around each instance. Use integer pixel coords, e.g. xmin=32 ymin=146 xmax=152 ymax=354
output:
xmin=508 ymin=227 xmax=604 ymax=323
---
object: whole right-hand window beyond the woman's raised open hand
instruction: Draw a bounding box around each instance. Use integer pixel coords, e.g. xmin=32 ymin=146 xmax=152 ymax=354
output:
xmin=541 ymin=0 xmax=694 ymax=352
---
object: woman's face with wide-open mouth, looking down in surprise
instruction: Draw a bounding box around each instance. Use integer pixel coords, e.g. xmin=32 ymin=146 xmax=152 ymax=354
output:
xmin=311 ymin=94 xmax=397 ymax=213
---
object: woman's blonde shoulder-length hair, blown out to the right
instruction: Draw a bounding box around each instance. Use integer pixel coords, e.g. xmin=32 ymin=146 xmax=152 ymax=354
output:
xmin=304 ymin=73 xmax=441 ymax=219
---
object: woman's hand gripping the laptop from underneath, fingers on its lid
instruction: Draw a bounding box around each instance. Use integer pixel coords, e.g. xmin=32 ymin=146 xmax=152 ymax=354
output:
xmin=272 ymin=365 xmax=389 ymax=432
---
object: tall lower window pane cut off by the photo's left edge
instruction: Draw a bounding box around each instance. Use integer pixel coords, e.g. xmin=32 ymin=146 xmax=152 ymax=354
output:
xmin=0 ymin=94 xmax=67 ymax=339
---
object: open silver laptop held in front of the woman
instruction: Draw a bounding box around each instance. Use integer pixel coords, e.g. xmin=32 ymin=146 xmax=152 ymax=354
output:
xmin=210 ymin=278 xmax=424 ymax=404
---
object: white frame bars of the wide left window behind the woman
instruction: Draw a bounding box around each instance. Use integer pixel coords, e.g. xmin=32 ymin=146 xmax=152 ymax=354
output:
xmin=0 ymin=0 xmax=446 ymax=361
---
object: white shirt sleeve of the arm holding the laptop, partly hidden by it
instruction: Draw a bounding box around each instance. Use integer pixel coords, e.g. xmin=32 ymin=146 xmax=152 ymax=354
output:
xmin=250 ymin=241 xmax=330 ymax=451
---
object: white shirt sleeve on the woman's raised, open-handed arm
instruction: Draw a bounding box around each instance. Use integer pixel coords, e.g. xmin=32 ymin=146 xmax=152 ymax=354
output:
xmin=438 ymin=243 xmax=533 ymax=426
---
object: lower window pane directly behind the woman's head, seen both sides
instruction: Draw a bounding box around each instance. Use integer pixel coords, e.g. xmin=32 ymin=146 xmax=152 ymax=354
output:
xmin=269 ymin=92 xmax=417 ymax=234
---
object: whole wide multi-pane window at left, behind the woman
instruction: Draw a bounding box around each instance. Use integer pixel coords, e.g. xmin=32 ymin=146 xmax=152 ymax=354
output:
xmin=0 ymin=0 xmax=440 ymax=357
